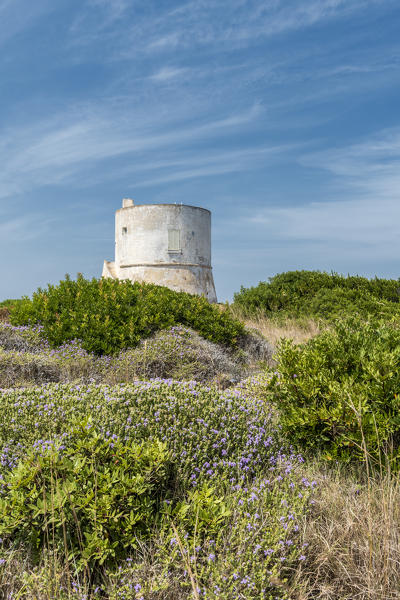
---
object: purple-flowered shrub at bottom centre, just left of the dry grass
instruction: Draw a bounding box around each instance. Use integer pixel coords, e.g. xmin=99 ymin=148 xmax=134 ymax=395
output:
xmin=159 ymin=475 xmax=315 ymax=600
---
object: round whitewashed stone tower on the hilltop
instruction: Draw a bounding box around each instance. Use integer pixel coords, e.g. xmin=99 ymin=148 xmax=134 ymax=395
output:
xmin=102 ymin=199 xmax=217 ymax=302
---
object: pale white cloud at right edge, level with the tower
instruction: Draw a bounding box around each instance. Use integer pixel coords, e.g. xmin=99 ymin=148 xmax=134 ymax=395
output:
xmin=248 ymin=128 xmax=400 ymax=259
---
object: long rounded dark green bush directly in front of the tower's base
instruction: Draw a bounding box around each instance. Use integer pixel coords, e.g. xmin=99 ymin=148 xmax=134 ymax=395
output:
xmin=11 ymin=276 xmax=244 ymax=354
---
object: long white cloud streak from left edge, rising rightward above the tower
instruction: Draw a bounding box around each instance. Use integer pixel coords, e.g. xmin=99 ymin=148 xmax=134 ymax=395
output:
xmin=0 ymin=104 xmax=262 ymax=197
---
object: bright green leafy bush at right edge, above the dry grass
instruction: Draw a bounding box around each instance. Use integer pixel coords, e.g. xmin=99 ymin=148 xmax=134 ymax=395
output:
xmin=272 ymin=317 xmax=400 ymax=468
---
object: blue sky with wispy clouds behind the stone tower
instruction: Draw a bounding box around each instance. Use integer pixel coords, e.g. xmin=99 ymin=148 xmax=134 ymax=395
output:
xmin=0 ymin=0 xmax=400 ymax=300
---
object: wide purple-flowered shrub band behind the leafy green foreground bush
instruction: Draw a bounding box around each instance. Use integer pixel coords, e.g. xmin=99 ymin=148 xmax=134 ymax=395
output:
xmin=0 ymin=380 xmax=276 ymax=486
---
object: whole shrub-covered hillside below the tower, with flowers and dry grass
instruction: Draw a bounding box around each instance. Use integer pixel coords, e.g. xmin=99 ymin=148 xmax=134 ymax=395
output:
xmin=0 ymin=274 xmax=400 ymax=600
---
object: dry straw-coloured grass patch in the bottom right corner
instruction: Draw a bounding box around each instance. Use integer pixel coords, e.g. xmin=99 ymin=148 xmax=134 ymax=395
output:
xmin=291 ymin=464 xmax=400 ymax=600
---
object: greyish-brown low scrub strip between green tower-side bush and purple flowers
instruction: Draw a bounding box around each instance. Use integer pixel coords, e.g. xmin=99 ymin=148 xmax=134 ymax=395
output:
xmin=0 ymin=323 xmax=272 ymax=388
